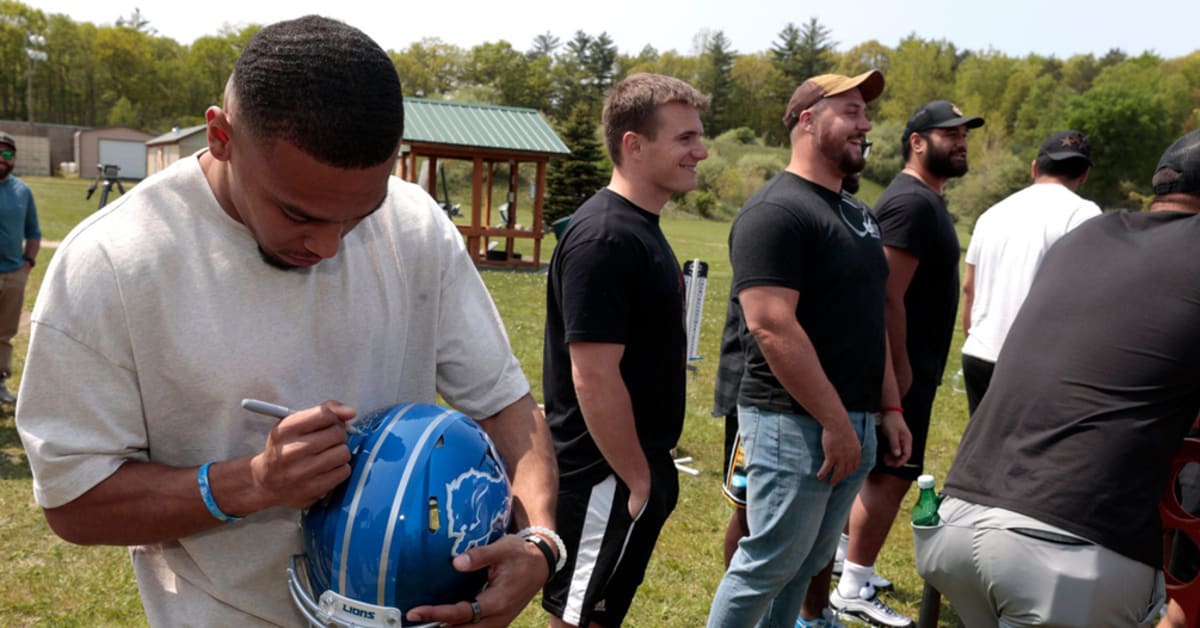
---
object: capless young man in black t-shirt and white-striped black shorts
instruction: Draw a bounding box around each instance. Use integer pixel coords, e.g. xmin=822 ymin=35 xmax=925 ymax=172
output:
xmin=542 ymin=74 xmax=708 ymax=627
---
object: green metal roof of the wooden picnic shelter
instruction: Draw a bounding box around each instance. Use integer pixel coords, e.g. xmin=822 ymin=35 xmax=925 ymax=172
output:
xmin=404 ymin=98 xmax=571 ymax=155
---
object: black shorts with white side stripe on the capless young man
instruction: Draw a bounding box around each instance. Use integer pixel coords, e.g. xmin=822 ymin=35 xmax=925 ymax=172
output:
xmin=541 ymin=453 xmax=679 ymax=627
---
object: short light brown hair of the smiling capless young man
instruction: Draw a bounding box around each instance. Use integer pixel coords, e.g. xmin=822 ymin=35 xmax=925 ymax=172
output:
xmin=604 ymin=72 xmax=708 ymax=166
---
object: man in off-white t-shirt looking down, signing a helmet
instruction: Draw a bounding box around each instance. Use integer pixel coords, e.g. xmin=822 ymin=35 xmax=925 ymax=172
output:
xmin=17 ymin=16 xmax=557 ymax=627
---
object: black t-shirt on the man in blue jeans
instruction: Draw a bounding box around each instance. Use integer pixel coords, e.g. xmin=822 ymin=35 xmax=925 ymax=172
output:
xmin=730 ymin=171 xmax=888 ymax=414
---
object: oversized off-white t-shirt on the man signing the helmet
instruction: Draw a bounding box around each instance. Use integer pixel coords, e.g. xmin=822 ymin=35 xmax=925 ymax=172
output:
xmin=18 ymin=156 xmax=529 ymax=627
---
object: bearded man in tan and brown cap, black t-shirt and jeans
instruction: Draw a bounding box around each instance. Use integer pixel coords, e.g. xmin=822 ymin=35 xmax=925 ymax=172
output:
xmin=708 ymin=71 xmax=910 ymax=628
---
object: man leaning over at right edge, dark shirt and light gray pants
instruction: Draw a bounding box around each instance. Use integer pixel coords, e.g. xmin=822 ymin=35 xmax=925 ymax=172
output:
xmin=914 ymin=131 xmax=1200 ymax=627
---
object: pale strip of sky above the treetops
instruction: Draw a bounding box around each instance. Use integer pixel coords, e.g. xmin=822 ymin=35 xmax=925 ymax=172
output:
xmin=32 ymin=0 xmax=1200 ymax=59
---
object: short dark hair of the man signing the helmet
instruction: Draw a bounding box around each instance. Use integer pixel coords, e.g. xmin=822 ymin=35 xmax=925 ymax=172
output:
xmin=229 ymin=16 xmax=404 ymax=168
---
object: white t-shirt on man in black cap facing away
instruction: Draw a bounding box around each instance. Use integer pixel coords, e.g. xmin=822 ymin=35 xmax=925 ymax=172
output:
xmin=962 ymin=184 xmax=1100 ymax=361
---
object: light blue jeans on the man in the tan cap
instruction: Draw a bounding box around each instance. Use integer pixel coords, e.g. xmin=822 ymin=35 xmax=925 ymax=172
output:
xmin=708 ymin=406 xmax=876 ymax=628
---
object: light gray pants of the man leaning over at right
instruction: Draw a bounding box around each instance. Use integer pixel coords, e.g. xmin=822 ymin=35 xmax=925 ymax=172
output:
xmin=913 ymin=496 xmax=1166 ymax=628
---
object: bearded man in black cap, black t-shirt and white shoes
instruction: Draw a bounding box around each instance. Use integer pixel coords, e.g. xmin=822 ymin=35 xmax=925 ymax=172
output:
xmin=830 ymin=101 xmax=983 ymax=627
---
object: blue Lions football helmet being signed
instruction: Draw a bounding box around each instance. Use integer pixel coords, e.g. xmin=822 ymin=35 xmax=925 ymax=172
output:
xmin=295 ymin=403 xmax=511 ymax=627
